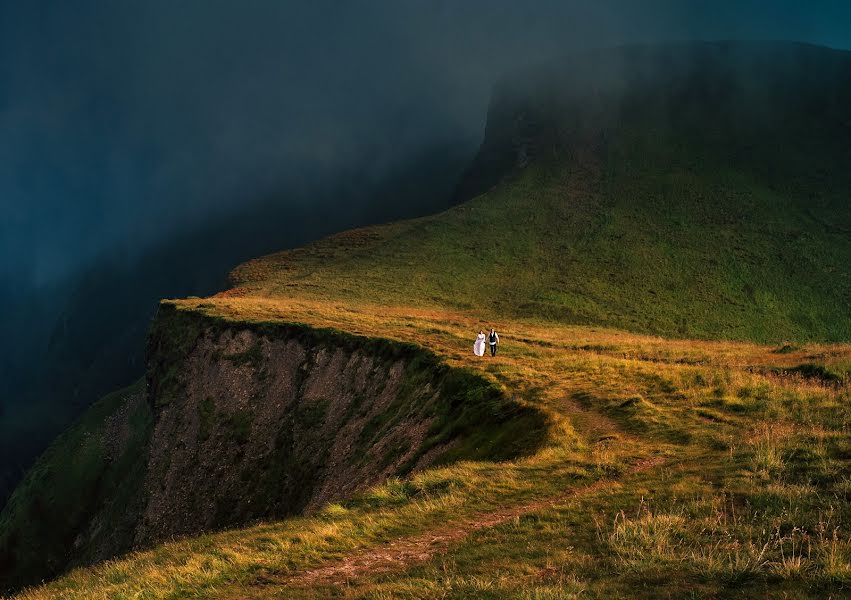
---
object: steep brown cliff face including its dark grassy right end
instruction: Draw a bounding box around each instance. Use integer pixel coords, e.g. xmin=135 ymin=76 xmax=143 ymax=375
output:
xmin=136 ymin=304 xmax=543 ymax=544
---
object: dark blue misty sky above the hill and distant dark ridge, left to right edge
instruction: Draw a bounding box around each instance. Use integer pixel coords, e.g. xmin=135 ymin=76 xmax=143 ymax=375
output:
xmin=0 ymin=0 xmax=851 ymax=287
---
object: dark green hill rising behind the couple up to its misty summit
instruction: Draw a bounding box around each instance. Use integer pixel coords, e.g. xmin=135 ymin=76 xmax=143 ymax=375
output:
xmin=226 ymin=42 xmax=851 ymax=343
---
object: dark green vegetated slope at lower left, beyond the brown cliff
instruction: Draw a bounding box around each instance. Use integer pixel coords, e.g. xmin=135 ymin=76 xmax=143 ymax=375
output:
xmin=0 ymin=381 xmax=153 ymax=589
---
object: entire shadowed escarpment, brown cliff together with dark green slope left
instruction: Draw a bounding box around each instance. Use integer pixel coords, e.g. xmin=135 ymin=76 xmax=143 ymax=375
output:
xmin=0 ymin=303 xmax=547 ymax=590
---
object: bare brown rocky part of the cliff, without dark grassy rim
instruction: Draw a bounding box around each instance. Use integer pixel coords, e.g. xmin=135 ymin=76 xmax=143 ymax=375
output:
xmin=136 ymin=312 xmax=453 ymax=544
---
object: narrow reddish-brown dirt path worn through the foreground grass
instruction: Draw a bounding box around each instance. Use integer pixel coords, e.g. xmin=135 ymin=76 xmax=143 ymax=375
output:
xmin=262 ymin=457 xmax=665 ymax=587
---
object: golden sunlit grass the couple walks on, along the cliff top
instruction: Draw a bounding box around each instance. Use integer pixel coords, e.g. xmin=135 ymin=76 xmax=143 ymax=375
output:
xmin=13 ymin=284 xmax=851 ymax=599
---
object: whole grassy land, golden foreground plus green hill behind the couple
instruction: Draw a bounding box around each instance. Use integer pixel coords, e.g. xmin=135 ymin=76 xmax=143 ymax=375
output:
xmin=10 ymin=44 xmax=851 ymax=599
